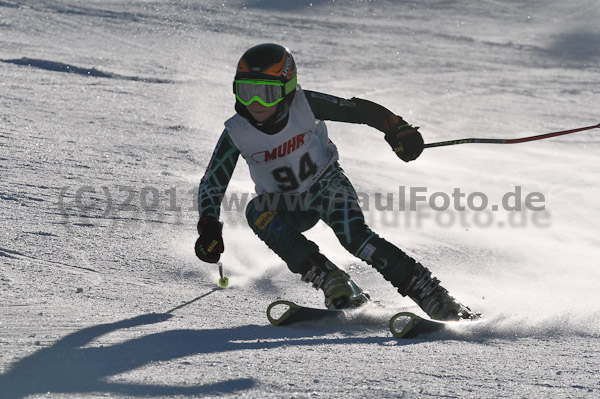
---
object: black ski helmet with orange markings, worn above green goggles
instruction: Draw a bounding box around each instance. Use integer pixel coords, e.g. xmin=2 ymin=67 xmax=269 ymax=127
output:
xmin=233 ymin=43 xmax=297 ymax=133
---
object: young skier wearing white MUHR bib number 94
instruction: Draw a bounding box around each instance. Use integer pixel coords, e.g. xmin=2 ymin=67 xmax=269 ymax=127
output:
xmin=195 ymin=43 xmax=473 ymax=320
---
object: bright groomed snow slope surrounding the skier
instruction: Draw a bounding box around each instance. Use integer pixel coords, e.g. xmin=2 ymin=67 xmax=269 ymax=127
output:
xmin=0 ymin=0 xmax=600 ymax=399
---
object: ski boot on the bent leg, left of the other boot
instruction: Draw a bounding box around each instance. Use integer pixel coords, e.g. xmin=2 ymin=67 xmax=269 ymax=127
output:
xmin=302 ymin=252 xmax=369 ymax=309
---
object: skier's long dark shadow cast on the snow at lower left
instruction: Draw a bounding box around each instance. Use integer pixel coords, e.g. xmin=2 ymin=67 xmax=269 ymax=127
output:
xmin=0 ymin=308 xmax=398 ymax=399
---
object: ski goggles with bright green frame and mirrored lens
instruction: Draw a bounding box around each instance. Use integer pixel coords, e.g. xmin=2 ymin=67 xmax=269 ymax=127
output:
xmin=233 ymin=76 xmax=297 ymax=107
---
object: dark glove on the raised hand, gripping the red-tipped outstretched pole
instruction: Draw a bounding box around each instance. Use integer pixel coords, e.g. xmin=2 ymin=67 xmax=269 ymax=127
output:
xmin=384 ymin=115 xmax=425 ymax=162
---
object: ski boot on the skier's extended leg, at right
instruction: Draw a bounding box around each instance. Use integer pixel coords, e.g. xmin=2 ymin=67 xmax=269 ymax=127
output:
xmin=398 ymin=263 xmax=478 ymax=321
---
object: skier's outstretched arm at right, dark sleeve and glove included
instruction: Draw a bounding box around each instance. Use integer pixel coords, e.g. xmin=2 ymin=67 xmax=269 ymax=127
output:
xmin=304 ymin=90 xmax=424 ymax=162
